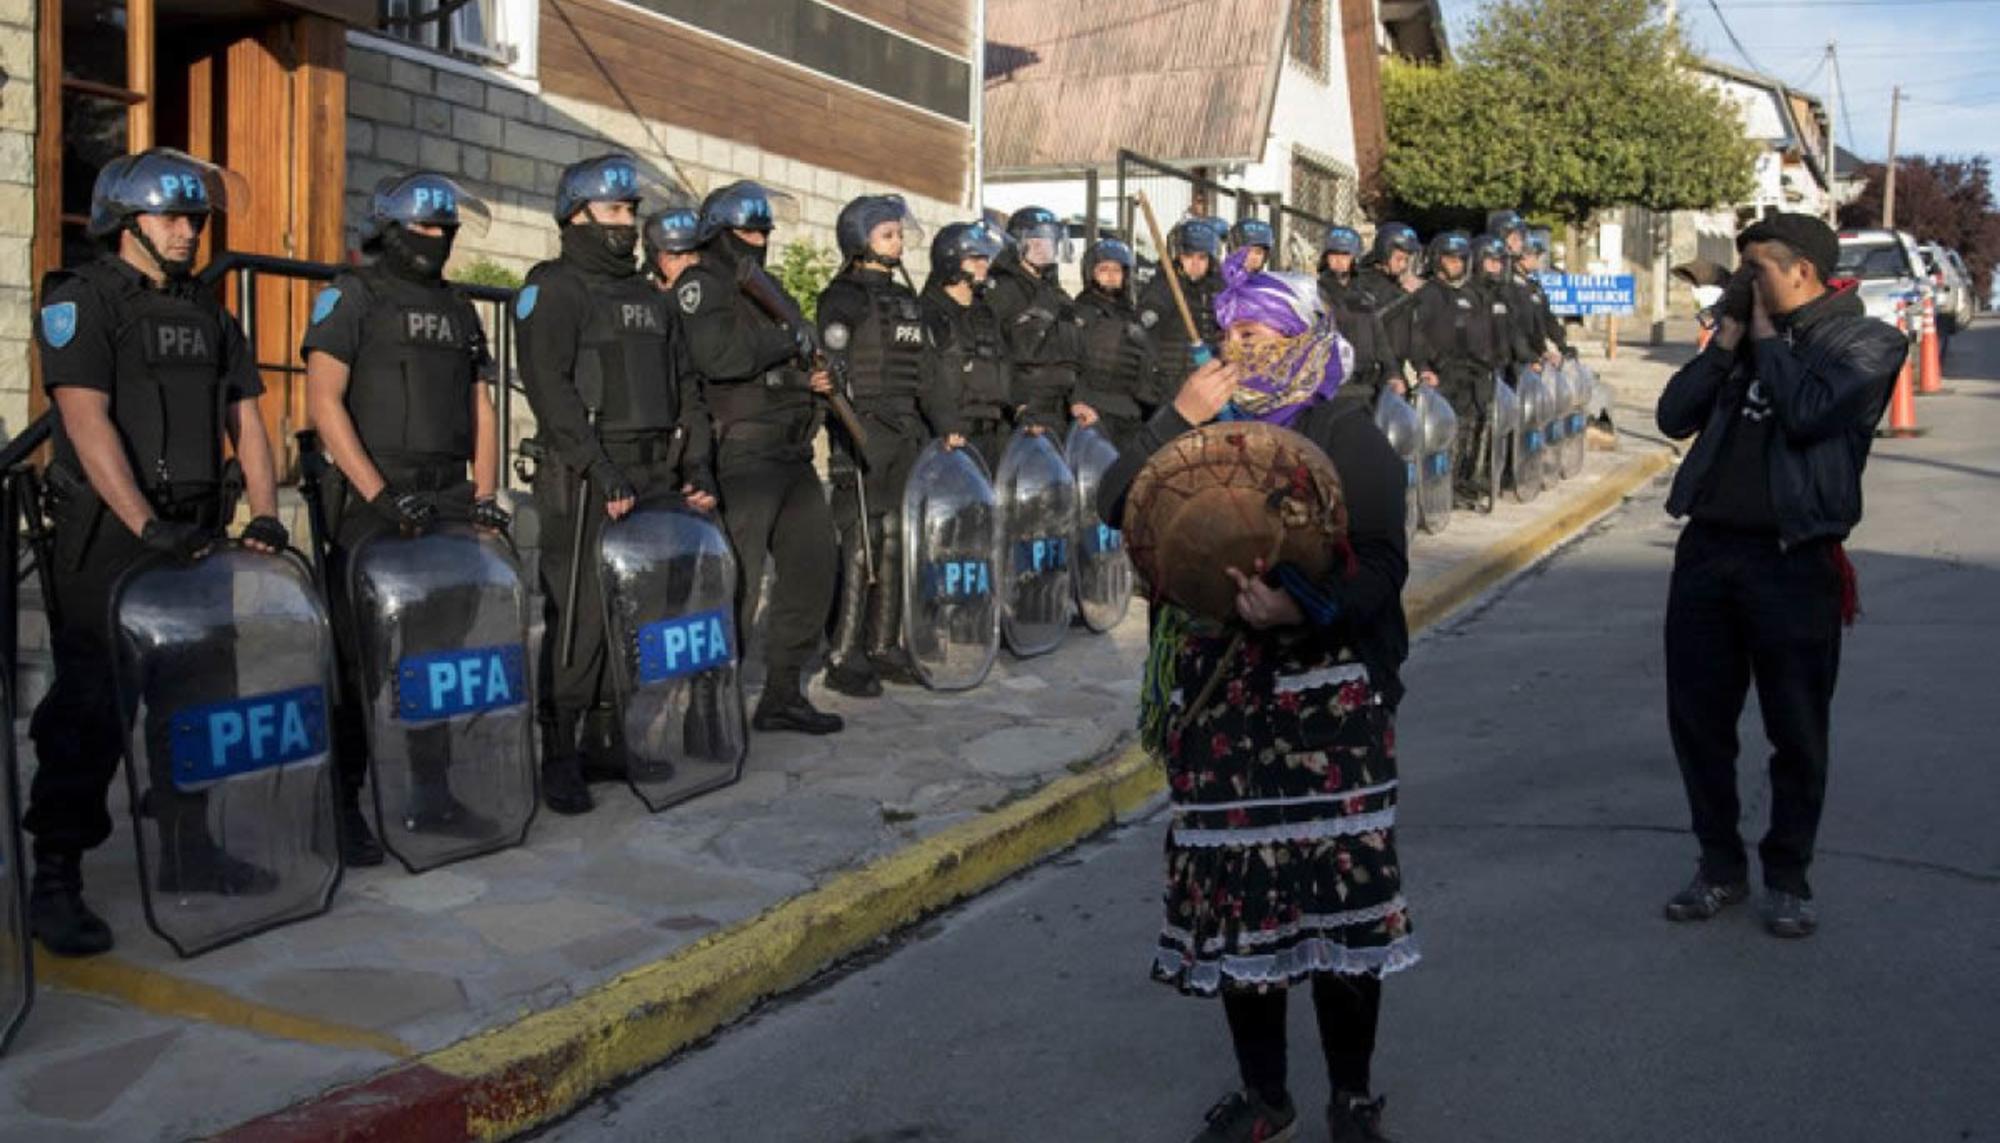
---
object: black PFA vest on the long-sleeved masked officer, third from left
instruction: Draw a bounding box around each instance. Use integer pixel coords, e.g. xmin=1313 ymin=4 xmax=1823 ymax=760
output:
xmin=558 ymin=264 xmax=680 ymax=434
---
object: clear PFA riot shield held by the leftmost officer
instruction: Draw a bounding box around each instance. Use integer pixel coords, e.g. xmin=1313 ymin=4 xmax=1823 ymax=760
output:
xmin=110 ymin=546 xmax=340 ymax=957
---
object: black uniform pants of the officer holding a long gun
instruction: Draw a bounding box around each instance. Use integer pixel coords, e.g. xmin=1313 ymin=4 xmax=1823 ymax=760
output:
xmin=716 ymin=455 xmax=840 ymax=691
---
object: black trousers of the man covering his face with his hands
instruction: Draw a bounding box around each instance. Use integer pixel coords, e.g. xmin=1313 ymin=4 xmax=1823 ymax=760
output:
xmin=1666 ymin=522 xmax=1844 ymax=897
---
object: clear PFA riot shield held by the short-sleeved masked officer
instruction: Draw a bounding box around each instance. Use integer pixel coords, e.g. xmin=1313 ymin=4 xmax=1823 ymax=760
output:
xmin=340 ymin=526 xmax=536 ymax=873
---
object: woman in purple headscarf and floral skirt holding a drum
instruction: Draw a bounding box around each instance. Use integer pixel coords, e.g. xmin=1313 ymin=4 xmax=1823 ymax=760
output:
xmin=1098 ymin=256 xmax=1418 ymax=1143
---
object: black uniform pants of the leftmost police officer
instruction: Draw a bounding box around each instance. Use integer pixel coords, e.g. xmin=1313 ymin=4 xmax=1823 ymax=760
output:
xmin=22 ymin=498 xmax=226 ymax=853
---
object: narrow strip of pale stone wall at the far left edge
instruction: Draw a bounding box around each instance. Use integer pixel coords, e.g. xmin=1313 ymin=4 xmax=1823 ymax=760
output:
xmin=0 ymin=0 xmax=36 ymax=440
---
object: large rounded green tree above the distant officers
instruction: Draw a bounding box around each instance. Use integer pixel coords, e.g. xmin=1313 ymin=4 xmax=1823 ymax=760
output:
xmin=1382 ymin=0 xmax=1758 ymax=226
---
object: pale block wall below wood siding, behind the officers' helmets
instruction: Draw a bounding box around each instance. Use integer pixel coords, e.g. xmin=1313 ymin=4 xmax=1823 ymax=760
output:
xmin=344 ymin=40 xmax=970 ymax=282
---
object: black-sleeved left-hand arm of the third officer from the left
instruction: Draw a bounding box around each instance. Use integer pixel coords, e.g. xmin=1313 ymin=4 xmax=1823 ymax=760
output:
xmin=514 ymin=274 xmax=624 ymax=483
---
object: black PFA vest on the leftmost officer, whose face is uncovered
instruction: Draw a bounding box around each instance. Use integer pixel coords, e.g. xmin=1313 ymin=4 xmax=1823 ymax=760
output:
xmin=70 ymin=260 xmax=234 ymax=495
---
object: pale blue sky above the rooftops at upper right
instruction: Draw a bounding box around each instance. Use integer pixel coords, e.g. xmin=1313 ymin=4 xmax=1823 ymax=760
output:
xmin=1440 ymin=0 xmax=2000 ymax=166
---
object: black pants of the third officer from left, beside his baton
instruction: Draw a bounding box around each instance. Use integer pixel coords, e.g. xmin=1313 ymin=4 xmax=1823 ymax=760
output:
xmin=534 ymin=456 xmax=680 ymax=723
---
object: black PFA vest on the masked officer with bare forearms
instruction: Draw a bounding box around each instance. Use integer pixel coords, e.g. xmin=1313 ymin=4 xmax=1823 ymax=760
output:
xmin=334 ymin=268 xmax=484 ymax=462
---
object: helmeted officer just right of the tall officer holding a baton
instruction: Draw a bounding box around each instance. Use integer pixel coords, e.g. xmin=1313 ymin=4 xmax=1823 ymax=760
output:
xmin=920 ymin=222 xmax=1022 ymax=474
